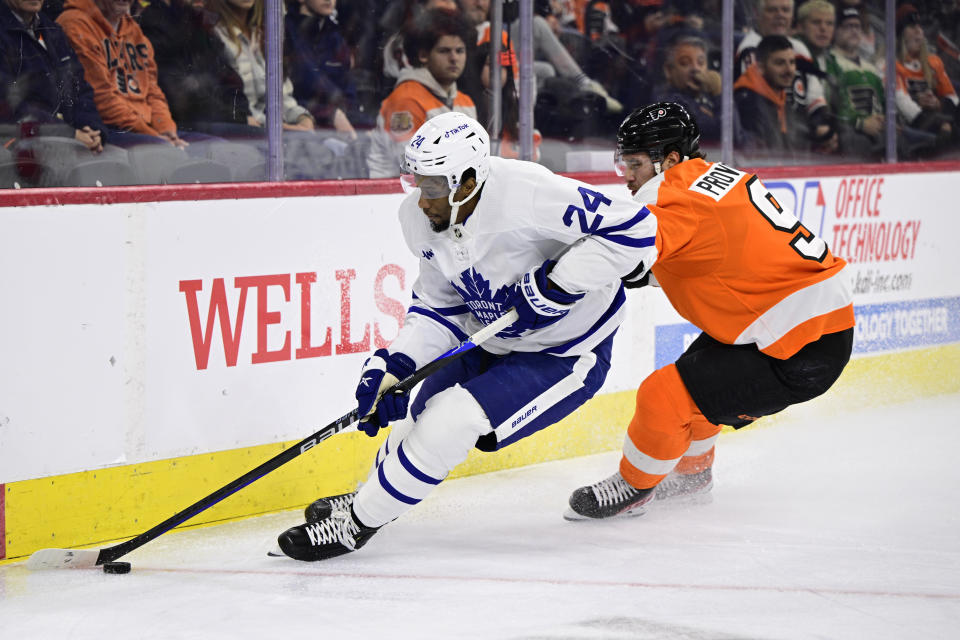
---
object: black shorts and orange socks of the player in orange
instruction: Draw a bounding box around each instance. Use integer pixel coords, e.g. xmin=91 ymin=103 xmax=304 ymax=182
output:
xmin=620 ymin=329 xmax=853 ymax=489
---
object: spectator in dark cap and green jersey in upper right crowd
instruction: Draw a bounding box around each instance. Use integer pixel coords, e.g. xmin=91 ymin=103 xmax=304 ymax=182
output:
xmin=826 ymin=7 xmax=885 ymax=158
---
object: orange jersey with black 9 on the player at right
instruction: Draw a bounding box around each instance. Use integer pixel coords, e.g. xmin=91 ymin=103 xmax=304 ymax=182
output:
xmin=635 ymin=159 xmax=854 ymax=359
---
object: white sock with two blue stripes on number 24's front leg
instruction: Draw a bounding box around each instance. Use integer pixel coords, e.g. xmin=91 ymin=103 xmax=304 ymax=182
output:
xmin=353 ymin=385 xmax=491 ymax=527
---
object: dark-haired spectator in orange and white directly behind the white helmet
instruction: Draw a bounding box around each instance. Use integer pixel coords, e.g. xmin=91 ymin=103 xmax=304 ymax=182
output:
xmin=367 ymin=9 xmax=477 ymax=178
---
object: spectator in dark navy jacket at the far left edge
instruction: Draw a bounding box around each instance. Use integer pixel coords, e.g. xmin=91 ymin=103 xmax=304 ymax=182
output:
xmin=0 ymin=0 xmax=106 ymax=153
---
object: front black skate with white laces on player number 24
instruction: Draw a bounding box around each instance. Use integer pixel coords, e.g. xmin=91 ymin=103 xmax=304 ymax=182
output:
xmin=277 ymin=509 xmax=377 ymax=562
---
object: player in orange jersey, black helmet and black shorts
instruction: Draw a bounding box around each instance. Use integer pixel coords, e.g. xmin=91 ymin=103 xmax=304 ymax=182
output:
xmin=565 ymin=103 xmax=854 ymax=520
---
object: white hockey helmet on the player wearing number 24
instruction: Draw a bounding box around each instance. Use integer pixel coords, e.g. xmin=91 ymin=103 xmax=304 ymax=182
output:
xmin=402 ymin=111 xmax=490 ymax=212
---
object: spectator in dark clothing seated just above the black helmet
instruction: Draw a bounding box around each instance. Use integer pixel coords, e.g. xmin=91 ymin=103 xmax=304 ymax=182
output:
xmin=655 ymin=36 xmax=721 ymax=143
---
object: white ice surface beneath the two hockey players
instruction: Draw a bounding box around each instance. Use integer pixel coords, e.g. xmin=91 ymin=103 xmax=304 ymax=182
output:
xmin=0 ymin=395 xmax=960 ymax=640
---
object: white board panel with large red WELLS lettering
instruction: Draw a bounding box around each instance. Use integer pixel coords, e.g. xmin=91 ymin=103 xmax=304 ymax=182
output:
xmin=142 ymin=195 xmax=417 ymax=458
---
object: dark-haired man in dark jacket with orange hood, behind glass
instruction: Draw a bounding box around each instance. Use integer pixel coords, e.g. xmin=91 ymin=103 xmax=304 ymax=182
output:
xmin=733 ymin=35 xmax=837 ymax=157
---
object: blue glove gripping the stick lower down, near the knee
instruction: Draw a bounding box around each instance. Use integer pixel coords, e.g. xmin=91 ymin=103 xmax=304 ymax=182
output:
xmin=356 ymin=349 xmax=417 ymax=438
